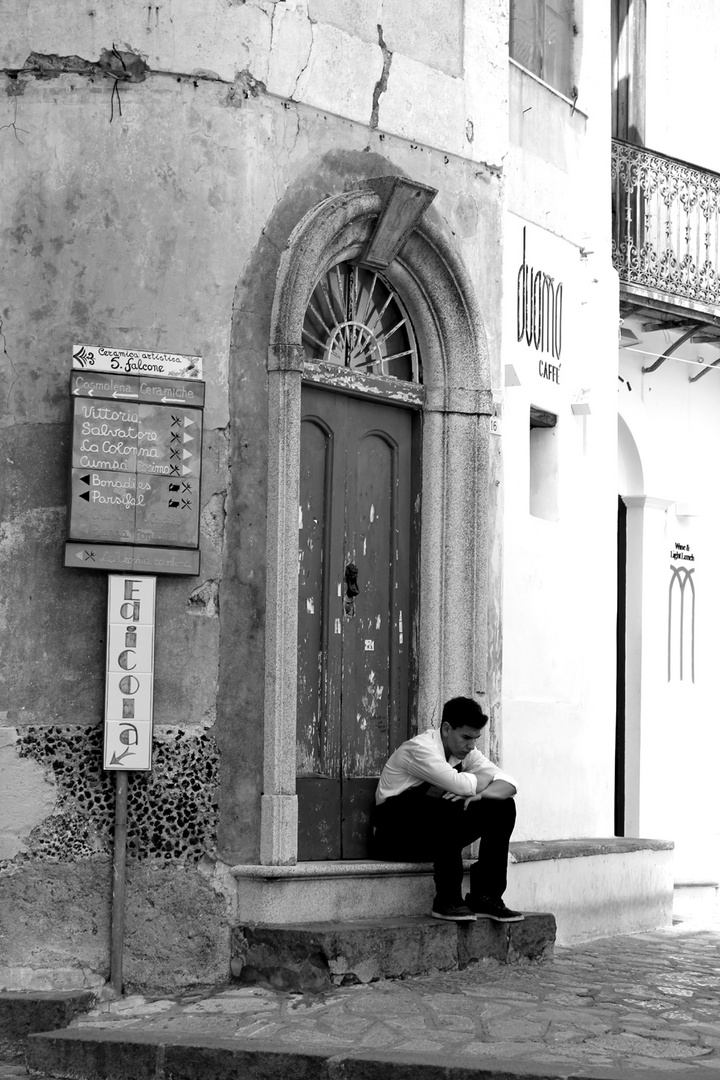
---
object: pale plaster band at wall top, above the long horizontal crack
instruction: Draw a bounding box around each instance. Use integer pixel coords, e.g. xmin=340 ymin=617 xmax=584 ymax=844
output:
xmin=0 ymin=0 xmax=507 ymax=164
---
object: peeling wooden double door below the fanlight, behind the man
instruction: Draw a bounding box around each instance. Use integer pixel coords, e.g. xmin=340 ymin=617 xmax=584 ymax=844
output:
xmin=297 ymin=387 xmax=420 ymax=860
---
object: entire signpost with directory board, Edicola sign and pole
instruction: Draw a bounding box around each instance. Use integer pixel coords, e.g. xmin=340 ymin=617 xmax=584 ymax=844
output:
xmin=65 ymin=345 xmax=205 ymax=994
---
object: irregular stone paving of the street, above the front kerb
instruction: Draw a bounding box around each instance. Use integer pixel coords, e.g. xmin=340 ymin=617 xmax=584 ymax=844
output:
xmin=7 ymin=919 xmax=720 ymax=1080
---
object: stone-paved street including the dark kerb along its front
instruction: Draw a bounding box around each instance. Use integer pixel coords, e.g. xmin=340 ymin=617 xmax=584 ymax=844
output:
xmin=16 ymin=920 xmax=720 ymax=1080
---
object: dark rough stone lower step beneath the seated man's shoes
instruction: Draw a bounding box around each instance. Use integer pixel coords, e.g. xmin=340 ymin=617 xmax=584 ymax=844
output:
xmin=231 ymin=912 xmax=556 ymax=993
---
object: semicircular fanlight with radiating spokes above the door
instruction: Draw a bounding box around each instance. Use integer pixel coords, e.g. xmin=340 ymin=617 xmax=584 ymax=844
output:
xmin=302 ymin=262 xmax=422 ymax=382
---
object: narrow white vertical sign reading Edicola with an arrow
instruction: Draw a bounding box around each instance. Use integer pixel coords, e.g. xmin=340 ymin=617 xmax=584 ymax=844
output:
xmin=104 ymin=573 xmax=155 ymax=771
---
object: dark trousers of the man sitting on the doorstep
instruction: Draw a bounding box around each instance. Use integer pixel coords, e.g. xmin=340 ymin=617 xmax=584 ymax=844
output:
xmin=373 ymin=784 xmax=516 ymax=904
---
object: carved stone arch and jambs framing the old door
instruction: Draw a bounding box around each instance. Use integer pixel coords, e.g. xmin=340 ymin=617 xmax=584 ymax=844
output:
xmin=260 ymin=185 xmax=501 ymax=865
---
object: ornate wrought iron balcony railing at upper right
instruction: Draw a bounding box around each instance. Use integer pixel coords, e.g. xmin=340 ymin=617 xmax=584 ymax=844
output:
xmin=612 ymin=139 xmax=720 ymax=314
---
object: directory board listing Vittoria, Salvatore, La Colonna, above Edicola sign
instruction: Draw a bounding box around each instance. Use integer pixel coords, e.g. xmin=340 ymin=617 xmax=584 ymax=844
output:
xmin=65 ymin=346 xmax=205 ymax=573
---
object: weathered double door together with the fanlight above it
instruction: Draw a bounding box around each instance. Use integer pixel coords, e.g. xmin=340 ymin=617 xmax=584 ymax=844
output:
xmin=297 ymin=262 xmax=422 ymax=860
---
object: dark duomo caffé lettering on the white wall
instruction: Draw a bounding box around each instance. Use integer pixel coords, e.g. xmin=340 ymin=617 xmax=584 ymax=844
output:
xmin=516 ymin=227 xmax=562 ymax=384
